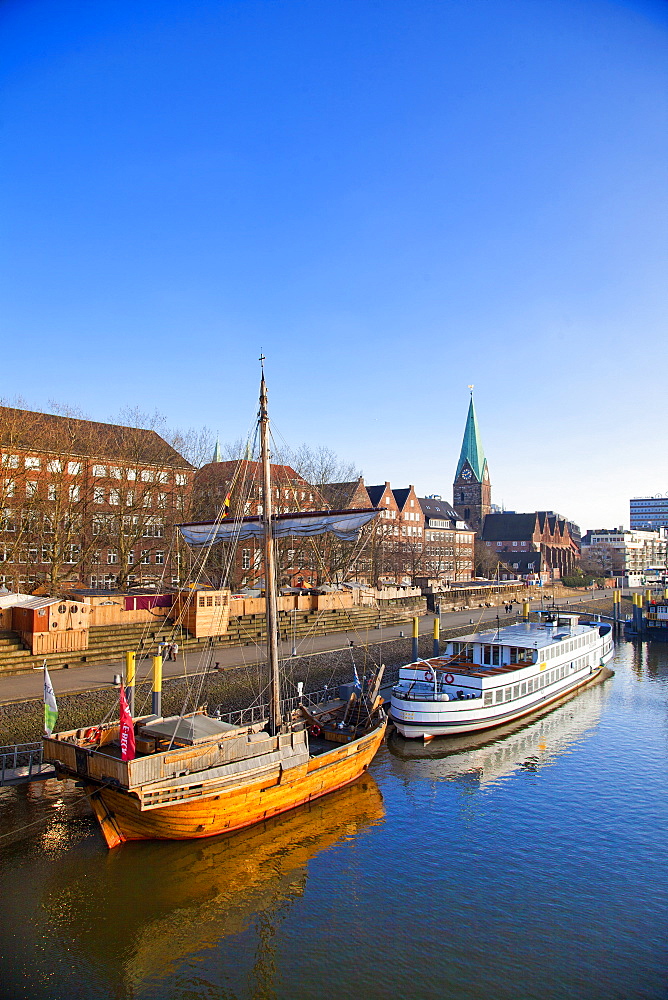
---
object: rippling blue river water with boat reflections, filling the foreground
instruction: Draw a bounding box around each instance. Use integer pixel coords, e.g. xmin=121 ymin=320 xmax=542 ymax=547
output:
xmin=0 ymin=642 xmax=668 ymax=1000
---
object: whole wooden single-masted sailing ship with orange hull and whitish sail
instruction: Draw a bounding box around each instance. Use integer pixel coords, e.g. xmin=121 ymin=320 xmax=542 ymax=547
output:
xmin=44 ymin=364 xmax=387 ymax=848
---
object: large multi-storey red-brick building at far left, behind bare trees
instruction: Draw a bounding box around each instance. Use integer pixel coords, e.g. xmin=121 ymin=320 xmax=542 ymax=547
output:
xmin=0 ymin=406 xmax=194 ymax=593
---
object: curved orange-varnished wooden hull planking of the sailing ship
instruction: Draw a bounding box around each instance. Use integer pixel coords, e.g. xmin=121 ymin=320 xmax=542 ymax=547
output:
xmin=85 ymin=722 xmax=386 ymax=848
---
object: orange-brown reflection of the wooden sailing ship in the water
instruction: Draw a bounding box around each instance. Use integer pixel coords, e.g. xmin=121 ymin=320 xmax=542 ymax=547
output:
xmin=36 ymin=774 xmax=385 ymax=993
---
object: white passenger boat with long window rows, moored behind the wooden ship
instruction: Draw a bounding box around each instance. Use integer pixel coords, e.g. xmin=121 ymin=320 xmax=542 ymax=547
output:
xmin=391 ymin=614 xmax=614 ymax=740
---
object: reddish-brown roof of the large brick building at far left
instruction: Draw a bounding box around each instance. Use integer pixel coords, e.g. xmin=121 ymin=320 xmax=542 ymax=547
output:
xmin=0 ymin=406 xmax=192 ymax=469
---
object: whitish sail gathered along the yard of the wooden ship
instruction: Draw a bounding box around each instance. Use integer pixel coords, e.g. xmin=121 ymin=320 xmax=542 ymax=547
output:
xmin=179 ymin=509 xmax=378 ymax=545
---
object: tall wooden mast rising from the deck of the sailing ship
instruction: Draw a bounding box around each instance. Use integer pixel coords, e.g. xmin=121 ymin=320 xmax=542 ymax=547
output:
xmin=259 ymin=355 xmax=282 ymax=736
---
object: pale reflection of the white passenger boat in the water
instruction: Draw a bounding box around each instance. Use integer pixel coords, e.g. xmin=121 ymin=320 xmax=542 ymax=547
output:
xmin=388 ymin=671 xmax=612 ymax=788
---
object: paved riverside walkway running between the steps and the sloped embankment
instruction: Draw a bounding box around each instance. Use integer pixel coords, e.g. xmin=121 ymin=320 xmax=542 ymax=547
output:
xmin=0 ymin=591 xmax=610 ymax=705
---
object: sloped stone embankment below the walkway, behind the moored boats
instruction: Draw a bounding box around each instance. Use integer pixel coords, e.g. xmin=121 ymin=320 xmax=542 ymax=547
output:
xmin=0 ymin=598 xmax=612 ymax=745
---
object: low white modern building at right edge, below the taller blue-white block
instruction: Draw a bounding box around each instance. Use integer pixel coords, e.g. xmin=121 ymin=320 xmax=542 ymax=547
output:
xmin=582 ymin=527 xmax=668 ymax=576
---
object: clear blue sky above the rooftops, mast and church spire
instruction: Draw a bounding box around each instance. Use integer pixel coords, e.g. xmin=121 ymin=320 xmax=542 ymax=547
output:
xmin=0 ymin=0 xmax=668 ymax=528
